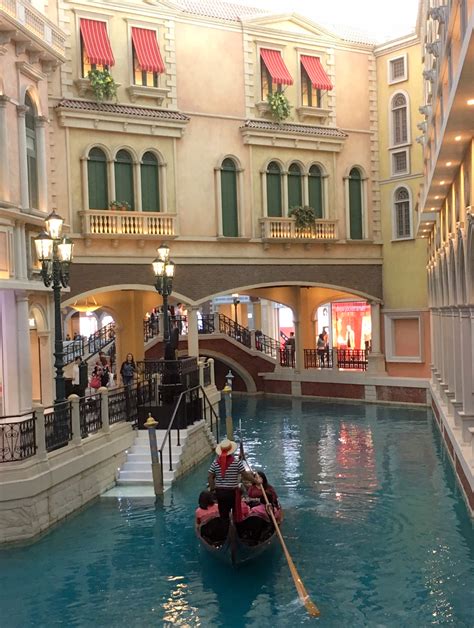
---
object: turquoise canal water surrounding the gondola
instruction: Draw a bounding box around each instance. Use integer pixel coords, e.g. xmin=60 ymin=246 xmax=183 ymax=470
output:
xmin=0 ymin=398 xmax=474 ymax=628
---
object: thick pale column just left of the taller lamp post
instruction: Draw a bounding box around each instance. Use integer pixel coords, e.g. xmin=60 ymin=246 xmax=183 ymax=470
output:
xmin=15 ymin=292 xmax=32 ymax=414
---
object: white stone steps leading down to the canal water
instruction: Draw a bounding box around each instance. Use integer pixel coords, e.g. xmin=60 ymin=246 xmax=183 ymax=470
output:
xmin=117 ymin=430 xmax=188 ymax=490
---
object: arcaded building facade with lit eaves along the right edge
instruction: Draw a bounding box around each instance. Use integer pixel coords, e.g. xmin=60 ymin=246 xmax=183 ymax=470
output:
xmin=417 ymin=0 xmax=474 ymax=509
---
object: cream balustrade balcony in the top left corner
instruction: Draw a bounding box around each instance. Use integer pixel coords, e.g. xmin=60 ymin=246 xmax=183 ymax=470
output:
xmin=0 ymin=0 xmax=66 ymax=63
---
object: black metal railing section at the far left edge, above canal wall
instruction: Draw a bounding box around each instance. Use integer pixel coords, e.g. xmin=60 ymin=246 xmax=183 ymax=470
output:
xmin=0 ymin=412 xmax=37 ymax=463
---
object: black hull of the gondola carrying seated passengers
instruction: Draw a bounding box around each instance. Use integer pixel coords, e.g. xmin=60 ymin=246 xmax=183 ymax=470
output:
xmin=196 ymin=516 xmax=277 ymax=565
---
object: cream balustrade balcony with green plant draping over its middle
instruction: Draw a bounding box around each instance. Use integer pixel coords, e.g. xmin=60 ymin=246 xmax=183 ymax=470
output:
xmin=260 ymin=218 xmax=338 ymax=244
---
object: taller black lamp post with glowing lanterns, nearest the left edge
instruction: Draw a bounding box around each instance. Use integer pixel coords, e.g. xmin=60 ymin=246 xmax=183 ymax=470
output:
xmin=35 ymin=212 xmax=73 ymax=404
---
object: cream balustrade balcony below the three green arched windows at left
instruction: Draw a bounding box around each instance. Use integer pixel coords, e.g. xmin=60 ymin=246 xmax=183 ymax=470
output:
xmin=80 ymin=209 xmax=177 ymax=238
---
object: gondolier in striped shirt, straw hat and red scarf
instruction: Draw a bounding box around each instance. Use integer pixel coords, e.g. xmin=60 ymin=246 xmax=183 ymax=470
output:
xmin=208 ymin=438 xmax=261 ymax=520
